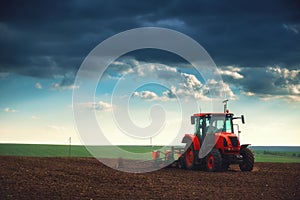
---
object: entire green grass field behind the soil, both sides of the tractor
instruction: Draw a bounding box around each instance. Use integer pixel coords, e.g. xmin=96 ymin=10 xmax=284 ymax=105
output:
xmin=0 ymin=144 xmax=300 ymax=163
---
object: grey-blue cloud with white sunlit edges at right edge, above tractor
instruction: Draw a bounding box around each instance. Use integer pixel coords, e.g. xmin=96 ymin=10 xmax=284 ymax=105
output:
xmin=222 ymin=66 xmax=300 ymax=102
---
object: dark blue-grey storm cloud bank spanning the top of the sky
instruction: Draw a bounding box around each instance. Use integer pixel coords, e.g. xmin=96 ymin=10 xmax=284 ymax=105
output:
xmin=0 ymin=0 xmax=300 ymax=77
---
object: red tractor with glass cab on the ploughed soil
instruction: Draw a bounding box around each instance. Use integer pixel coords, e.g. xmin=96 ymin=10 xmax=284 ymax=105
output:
xmin=179 ymin=106 xmax=254 ymax=172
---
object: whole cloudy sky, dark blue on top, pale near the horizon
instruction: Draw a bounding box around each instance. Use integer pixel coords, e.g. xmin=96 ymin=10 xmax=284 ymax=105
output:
xmin=0 ymin=0 xmax=300 ymax=146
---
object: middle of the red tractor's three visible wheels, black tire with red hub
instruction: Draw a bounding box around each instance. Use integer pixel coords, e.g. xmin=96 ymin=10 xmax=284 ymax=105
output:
xmin=205 ymin=149 xmax=222 ymax=172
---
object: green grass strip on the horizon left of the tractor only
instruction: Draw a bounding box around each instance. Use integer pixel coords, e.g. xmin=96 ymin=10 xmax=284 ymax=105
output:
xmin=0 ymin=144 xmax=161 ymax=159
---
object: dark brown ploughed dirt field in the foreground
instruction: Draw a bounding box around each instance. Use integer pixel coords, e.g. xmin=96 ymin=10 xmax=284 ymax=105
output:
xmin=0 ymin=157 xmax=300 ymax=200
